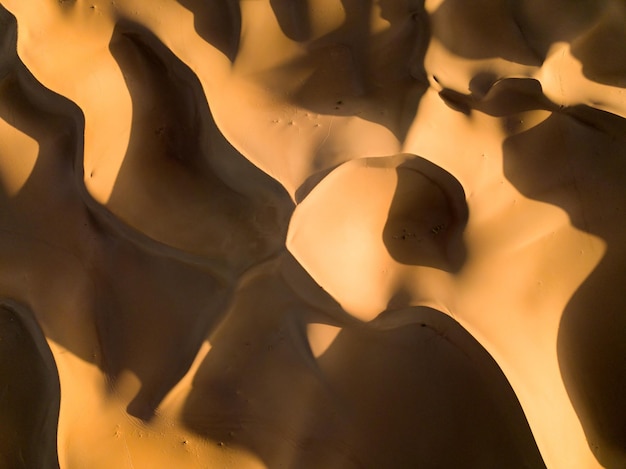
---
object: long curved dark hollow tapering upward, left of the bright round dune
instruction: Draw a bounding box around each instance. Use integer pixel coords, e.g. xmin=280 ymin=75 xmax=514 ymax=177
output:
xmin=107 ymin=22 xmax=293 ymax=277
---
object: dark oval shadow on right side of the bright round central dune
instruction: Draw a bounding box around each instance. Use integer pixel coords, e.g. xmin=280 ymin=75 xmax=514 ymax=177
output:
xmin=383 ymin=155 xmax=468 ymax=272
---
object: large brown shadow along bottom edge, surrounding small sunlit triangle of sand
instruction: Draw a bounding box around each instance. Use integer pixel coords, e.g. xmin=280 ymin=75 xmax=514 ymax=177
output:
xmin=182 ymin=258 xmax=545 ymax=469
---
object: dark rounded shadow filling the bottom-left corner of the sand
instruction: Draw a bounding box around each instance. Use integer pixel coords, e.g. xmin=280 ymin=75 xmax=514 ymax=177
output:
xmin=0 ymin=302 xmax=60 ymax=469
